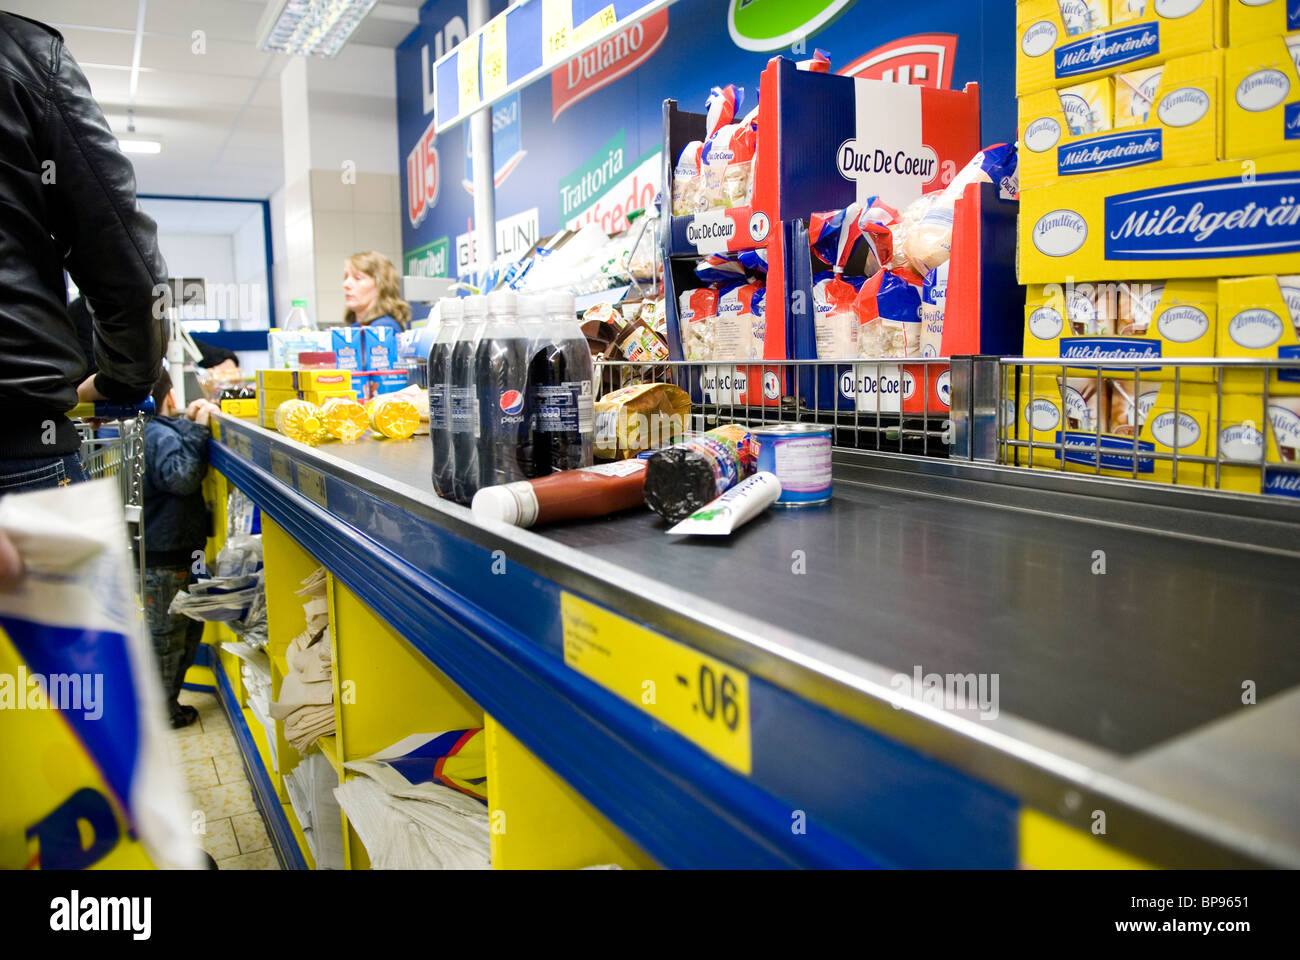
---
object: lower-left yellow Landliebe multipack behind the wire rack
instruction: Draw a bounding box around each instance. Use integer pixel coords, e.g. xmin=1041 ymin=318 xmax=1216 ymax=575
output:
xmin=1015 ymin=373 xmax=1214 ymax=487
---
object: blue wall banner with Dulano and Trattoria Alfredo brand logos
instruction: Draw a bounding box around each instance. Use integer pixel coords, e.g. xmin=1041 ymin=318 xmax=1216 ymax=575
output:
xmin=397 ymin=0 xmax=1017 ymax=269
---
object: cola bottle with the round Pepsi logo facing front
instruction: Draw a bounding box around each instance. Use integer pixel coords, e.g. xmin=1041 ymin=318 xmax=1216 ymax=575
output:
xmin=471 ymin=290 xmax=528 ymax=486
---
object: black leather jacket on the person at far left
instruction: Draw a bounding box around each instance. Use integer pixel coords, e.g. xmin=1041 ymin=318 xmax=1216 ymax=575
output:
xmin=0 ymin=12 xmax=168 ymax=459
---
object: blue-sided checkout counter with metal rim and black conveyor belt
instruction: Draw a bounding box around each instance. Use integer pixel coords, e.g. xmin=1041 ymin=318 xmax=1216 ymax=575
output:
xmin=212 ymin=418 xmax=1300 ymax=866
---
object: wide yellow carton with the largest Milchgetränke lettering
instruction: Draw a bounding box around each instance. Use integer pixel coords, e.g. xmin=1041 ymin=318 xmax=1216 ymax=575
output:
xmin=1019 ymin=153 xmax=1300 ymax=284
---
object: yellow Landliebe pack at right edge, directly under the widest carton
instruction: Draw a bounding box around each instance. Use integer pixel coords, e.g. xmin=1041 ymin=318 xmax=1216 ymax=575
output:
xmin=1217 ymin=276 xmax=1300 ymax=395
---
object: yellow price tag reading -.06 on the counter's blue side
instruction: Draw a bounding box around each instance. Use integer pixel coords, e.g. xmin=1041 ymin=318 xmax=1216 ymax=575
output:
xmin=560 ymin=593 xmax=751 ymax=775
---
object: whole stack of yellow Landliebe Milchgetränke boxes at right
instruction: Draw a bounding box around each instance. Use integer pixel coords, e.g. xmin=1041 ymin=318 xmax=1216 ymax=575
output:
xmin=1015 ymin=0 xmax=1300 ymax=496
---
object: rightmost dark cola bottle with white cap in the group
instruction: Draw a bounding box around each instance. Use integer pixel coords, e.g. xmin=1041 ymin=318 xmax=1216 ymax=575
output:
xmin=528 ymin=291 xmax=595 ymax=476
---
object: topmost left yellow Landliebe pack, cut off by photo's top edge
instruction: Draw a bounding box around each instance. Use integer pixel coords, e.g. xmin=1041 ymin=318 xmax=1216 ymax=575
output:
xmin=1015 ymin=0 xmax=1227 ymax=96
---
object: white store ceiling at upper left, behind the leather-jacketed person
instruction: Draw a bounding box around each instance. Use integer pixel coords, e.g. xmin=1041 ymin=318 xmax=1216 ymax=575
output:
xmin=4 ymin=0 xmax=423 ymax=199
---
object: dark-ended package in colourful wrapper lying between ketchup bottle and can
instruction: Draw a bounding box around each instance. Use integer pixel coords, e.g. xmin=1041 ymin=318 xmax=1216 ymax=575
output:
xmin=645 ymin=424 xmax=758 ymax=523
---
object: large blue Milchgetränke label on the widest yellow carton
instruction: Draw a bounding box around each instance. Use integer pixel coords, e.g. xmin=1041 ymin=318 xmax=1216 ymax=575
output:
xmin=1102 ymin=173 xmax=1300 ymax=260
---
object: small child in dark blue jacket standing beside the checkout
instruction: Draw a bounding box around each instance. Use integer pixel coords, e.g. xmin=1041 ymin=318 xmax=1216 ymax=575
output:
xmin=144 ymin=369 xmax=217 ymax=730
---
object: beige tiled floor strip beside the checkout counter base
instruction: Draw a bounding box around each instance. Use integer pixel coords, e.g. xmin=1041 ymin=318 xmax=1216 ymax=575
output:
xmin=169 ymin=689 xmax=280 ymax=870
